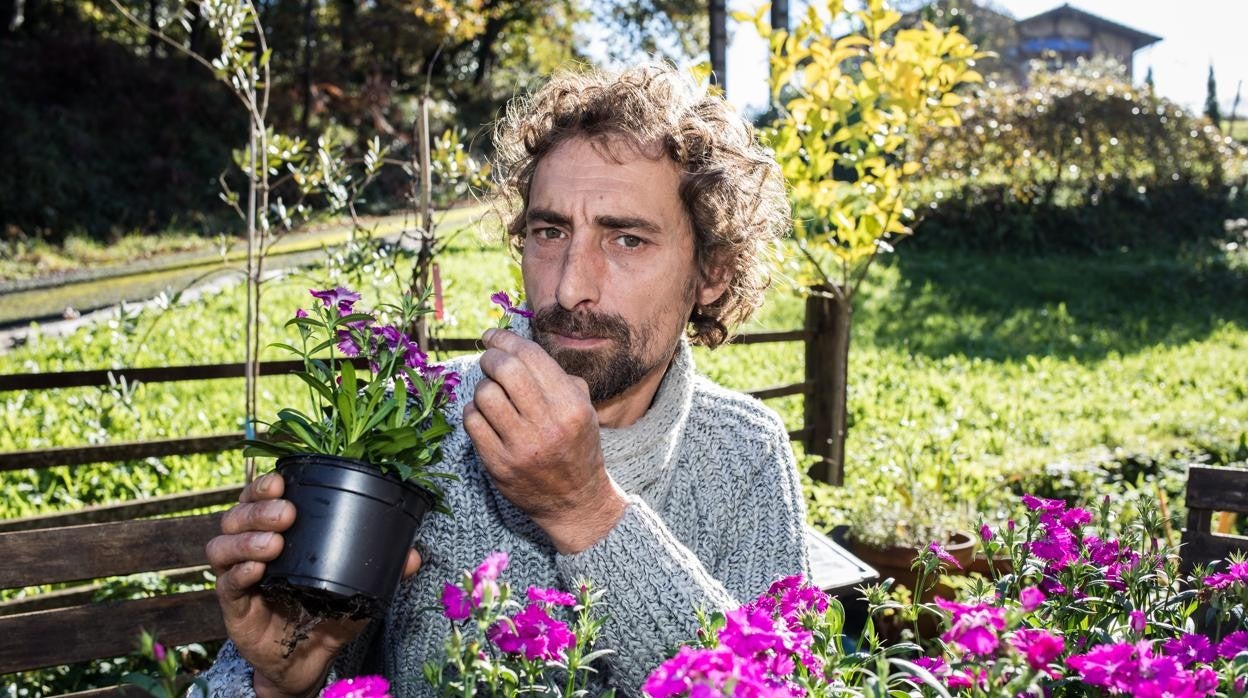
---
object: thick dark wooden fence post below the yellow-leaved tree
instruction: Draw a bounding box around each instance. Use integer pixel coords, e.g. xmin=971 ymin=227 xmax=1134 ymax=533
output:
xmin=806 ymin=287 xmax=852 ymax=484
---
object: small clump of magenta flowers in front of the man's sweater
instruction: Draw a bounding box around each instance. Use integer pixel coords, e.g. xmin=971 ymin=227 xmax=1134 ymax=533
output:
xmin=424 ymin=552 xmax=614 ymax=697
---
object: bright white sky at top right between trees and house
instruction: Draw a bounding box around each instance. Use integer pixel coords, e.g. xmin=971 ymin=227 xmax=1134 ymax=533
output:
xmin=726 ymin=0 xmax=1248 ymax=117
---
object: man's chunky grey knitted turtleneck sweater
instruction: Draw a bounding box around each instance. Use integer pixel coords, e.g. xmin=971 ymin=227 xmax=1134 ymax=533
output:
xmin=197 ymin=317 xmax=809 ymax=698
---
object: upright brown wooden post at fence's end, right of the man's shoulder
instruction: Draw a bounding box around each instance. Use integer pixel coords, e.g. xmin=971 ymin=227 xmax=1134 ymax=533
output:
xmin=805 ymin=293 xmax=844 ymax=486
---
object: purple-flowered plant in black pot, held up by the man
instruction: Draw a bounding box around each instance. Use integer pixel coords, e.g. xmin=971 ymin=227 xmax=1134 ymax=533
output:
xmin=245 ymin=287 xmax=459 ymax=621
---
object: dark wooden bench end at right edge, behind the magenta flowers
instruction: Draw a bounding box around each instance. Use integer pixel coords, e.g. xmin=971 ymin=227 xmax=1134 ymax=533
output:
xmin=1179 ymin=466 xmax=1248 ymax=573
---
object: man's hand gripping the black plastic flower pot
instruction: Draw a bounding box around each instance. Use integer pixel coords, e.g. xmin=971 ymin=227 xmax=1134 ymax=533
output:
xmin=206 ymin=473 xmax=421 ymax=698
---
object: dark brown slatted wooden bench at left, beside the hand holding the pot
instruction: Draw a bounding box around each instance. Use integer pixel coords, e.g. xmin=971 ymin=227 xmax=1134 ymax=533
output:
xmin=0 ymin=487 xmax=241 ymax=696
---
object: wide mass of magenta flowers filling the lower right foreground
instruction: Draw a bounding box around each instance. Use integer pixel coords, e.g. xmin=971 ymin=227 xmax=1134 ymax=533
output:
xmin=643 ymin=496 xmax=1248 ymax=698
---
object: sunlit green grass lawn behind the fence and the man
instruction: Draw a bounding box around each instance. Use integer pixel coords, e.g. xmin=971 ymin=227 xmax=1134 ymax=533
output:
xmin=0 ymin=228 xmax=1248 ymax=529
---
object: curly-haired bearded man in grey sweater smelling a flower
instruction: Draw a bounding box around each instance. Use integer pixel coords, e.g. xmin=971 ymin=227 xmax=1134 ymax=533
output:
xmin=207 ymin=66 xmax=807 ymax=696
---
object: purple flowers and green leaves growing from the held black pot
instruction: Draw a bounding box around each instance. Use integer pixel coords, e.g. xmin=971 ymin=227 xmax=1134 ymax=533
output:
xmin=246 ymin=287 xmax=459 ymax=492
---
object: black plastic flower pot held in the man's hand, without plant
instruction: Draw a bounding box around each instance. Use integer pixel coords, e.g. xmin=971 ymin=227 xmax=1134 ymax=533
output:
xmin=261 ymin=455 xmax=436 ymax=618
